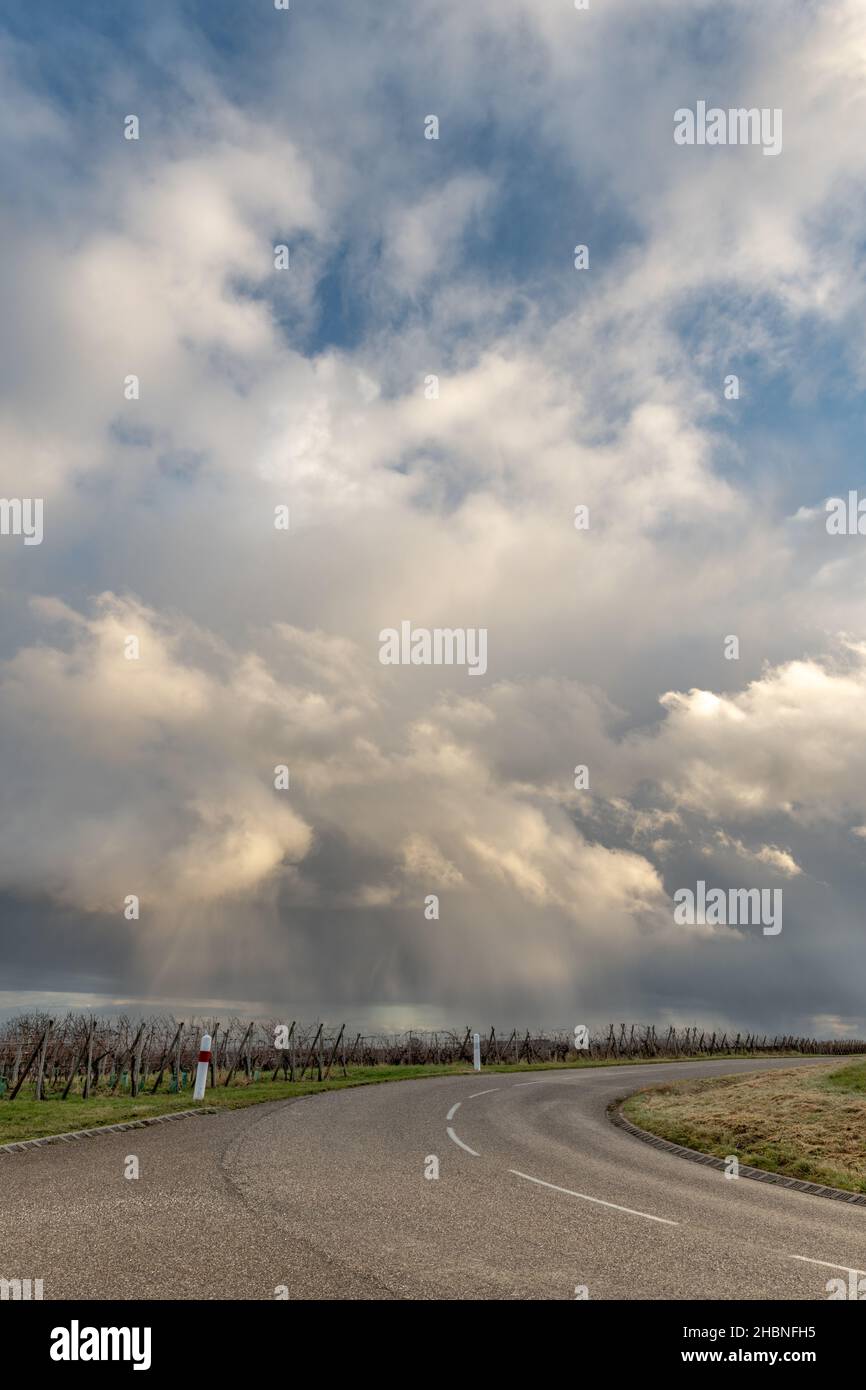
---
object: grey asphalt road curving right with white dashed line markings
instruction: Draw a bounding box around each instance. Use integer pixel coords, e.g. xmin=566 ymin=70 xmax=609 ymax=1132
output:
xmin=0 ymin=1061 xmax=866 ymax=1300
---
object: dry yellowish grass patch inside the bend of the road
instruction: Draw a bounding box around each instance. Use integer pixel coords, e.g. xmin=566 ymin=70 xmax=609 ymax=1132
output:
xmin=623 ymin=1061 xmax=866 ymax=1193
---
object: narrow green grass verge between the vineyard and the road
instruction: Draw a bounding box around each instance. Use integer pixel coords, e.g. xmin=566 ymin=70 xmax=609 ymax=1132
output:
xmin=0 ymin=1052 xmax=822 ymax=1144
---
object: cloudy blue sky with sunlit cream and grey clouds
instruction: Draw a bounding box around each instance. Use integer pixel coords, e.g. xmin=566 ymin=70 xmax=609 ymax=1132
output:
xmin=0 ymin=0 xmax=866 ymax=1037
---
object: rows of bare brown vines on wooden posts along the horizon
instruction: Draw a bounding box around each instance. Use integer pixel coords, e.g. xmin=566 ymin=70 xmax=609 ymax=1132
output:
xmin=0 ymin=1013 xmax=866 ymax=1101
